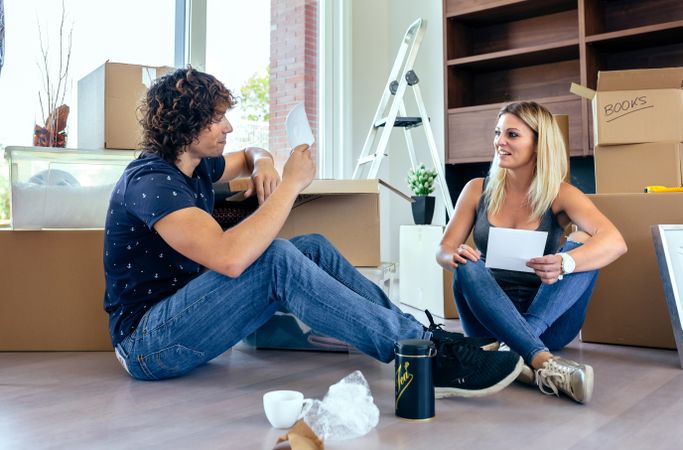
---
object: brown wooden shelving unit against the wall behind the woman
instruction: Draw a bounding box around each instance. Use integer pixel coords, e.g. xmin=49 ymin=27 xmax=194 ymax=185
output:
xmin=443 ymin=0 xmax=683 ymax=164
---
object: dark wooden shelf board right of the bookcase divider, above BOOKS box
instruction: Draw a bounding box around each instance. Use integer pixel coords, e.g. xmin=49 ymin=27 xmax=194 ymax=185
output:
xmin=586 ymin=20 xmax=683 ymax=50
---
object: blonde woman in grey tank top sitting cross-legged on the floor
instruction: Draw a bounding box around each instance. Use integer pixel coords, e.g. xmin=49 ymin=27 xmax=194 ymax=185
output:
xmin=437 ymin=102 xmax=626 ymax=403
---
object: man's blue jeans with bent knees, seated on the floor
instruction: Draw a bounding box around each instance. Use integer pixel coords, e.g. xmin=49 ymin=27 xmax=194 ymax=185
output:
xmin=116 ymin=234 xmax=431 ymax=380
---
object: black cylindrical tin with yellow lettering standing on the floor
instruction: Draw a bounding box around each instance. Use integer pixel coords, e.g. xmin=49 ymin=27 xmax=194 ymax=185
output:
xmin=394 ymin=339 xmax=436 ymax=420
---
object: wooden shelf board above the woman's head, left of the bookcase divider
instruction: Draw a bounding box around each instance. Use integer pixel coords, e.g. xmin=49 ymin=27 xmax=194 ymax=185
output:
xmin=447 ymin=39 xmax=579 ymax=70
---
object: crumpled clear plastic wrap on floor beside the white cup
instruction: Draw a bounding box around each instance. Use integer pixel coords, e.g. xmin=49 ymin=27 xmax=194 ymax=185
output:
xmin=303 ymin=370 xmax=379 ymax=441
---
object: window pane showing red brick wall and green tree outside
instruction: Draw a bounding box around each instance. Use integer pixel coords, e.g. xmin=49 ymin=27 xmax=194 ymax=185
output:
xmin=205 ymin=0 xmax=319 ymax=172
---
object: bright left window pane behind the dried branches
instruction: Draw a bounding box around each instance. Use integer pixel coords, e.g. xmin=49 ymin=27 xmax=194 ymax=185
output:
xmin=0 ymin=0 xmax=175 ymax=147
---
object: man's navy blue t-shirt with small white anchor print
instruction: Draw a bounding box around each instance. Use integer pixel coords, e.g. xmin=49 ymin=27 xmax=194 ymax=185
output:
xmin=104 ymin=154 xmax=225 ymax=345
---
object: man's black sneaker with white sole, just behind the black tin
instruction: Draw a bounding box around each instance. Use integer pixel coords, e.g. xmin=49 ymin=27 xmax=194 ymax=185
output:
xmin=432 ymin=334 xmax=524 ymax=398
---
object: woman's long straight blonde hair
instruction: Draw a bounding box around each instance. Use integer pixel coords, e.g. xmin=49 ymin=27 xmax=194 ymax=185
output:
xmin=484 ymin=102 xmax=567 ymax=220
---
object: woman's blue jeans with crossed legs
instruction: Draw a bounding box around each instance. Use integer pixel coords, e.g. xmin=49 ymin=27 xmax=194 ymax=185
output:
xmin=453 ymin=241 xmax=598 ymax=364
